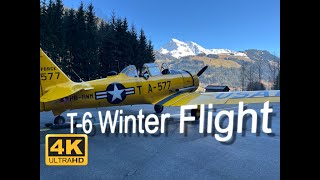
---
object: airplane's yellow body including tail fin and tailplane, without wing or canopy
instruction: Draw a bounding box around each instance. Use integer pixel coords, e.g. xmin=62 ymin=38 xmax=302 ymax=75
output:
xmin=40 ymin=49 xmax=197 ymax=115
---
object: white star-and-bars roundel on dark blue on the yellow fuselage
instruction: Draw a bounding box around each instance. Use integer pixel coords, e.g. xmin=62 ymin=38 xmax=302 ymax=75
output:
xmin=95 ymin=83 xmax=135 ymax=104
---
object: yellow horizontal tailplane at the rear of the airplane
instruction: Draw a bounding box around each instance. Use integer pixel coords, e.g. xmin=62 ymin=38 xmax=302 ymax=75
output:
xmin=40 ymin=82 xmax=93 ymax=102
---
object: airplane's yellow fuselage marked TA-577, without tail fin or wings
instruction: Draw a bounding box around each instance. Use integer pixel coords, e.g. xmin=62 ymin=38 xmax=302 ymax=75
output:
xmin=40 ymin=71 xmax=199 ymax=115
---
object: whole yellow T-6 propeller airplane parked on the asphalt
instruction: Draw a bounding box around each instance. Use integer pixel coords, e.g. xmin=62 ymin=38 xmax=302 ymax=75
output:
xmin=40 ymin=48 xmax=280 ymax=124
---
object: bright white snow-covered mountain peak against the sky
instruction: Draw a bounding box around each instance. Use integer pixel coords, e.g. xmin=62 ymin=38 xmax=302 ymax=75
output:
xmin=159 ymin=39 xmax=247 ymax=58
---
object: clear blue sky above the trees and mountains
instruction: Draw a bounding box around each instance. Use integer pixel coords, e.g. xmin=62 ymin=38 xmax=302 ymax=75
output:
xmin=63 ymin=0 xmax=280 ymax=56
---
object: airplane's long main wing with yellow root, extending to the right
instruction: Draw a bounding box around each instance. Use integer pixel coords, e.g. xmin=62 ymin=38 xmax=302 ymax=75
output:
xmin=156 ymin=90 xmax=280 ymax=106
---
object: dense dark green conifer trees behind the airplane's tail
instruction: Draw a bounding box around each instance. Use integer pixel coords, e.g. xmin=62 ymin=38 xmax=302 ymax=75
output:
xmin=40 ymin=0 xmax=155 ymax=81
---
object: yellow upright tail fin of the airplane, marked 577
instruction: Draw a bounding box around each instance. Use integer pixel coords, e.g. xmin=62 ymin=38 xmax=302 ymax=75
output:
xmin=40 ymin=48 xmax=73 ymax=92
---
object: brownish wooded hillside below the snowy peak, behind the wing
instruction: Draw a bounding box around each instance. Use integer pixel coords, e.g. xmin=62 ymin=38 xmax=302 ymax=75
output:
xmin=155 ymin=49 xmax=280 ymax=91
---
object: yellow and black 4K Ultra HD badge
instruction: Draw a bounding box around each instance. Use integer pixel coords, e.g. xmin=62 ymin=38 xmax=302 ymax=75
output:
xmin=45 ymin=134 xmax=88 ymax=166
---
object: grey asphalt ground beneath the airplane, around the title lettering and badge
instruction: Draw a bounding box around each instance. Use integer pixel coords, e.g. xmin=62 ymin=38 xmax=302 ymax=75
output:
xmin=40 ymin=103 xmax=280 ymax=180
